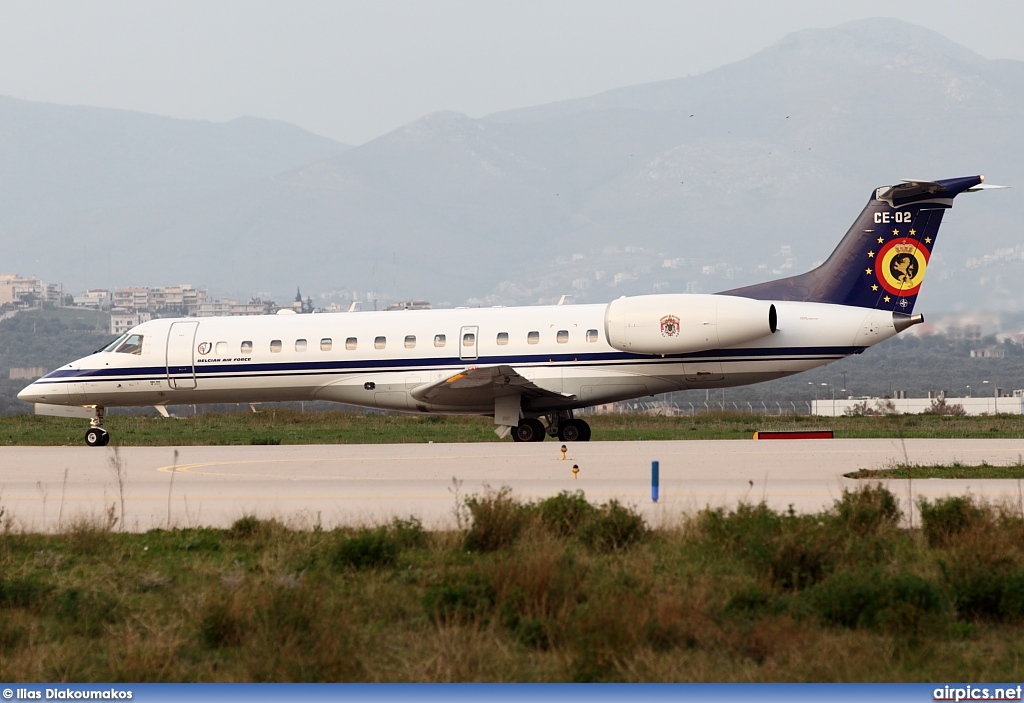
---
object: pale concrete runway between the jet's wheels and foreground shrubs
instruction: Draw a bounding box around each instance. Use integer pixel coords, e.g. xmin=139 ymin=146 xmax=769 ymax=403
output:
xmin=0 ymin=439 xmax=1024 ymax=531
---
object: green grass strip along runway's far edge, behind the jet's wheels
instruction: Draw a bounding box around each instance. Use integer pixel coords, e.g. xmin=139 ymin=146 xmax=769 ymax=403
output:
xmin=0 ymin=407 xmax=1024 ymax=446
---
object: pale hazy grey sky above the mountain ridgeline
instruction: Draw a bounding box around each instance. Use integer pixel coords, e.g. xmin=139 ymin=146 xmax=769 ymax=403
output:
xmin=0 ymin=0 xmax=1024 ymax=144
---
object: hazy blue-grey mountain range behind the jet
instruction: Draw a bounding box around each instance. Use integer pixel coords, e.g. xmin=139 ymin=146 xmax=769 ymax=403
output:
xmin=0 ymin=19 xmax=1024 ymax=311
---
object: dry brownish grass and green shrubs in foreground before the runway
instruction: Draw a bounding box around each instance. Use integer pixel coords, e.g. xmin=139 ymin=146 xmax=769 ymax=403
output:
xmin=0 ymin=487 xmax=1024 ymax=682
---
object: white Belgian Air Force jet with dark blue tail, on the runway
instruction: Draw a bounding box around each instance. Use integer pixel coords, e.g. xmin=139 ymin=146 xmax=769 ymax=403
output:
xmin=17 ymin=176 xmax=999 ymax=446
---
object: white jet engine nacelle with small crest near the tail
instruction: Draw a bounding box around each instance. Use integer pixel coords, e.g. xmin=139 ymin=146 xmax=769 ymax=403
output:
xmin=604 ymin=294 xmax=778 ymax=354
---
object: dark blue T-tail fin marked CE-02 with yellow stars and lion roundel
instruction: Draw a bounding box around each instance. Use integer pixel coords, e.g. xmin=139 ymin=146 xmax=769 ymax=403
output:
xmin=724 ymin=176 xmax=1000 ymax=314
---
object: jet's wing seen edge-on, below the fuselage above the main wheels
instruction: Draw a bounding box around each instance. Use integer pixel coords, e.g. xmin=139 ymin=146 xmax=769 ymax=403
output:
xmin=410 ymin=365 xmax=572 ymax=406
